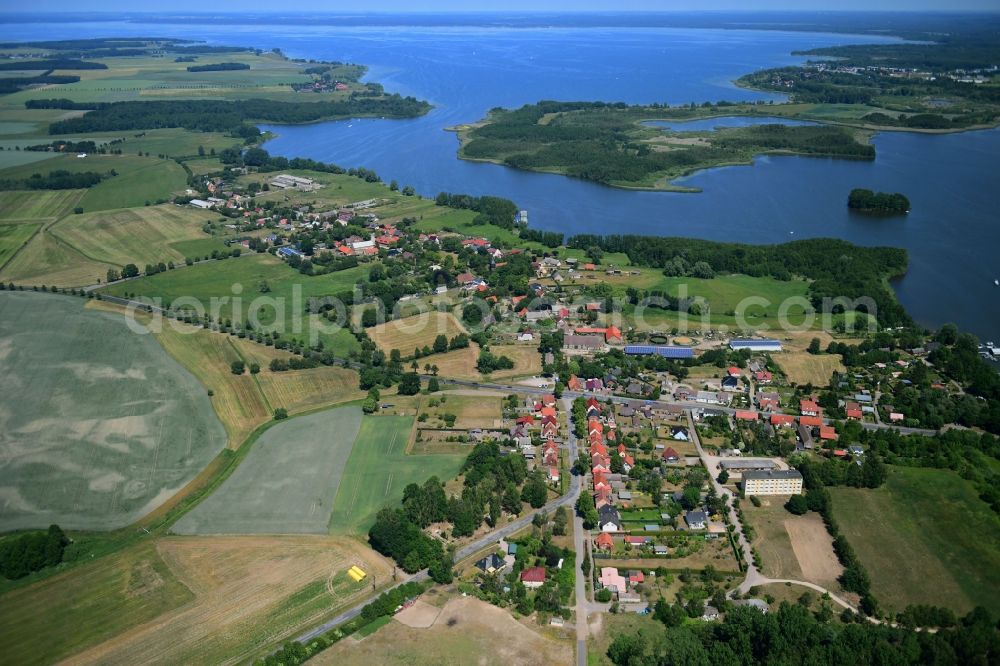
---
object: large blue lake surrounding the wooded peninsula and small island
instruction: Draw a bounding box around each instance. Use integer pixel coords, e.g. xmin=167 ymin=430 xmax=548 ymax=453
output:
xmin=2 ymin=18 xmax=1000 ymax=339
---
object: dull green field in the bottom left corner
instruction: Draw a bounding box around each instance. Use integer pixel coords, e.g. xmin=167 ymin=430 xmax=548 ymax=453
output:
xmin=0 ymin=542 xmax=194 ymax=664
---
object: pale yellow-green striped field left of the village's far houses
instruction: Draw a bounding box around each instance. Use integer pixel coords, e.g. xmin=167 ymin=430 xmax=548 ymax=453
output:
xmin=49 ymin=204 xmax=224 ymax=267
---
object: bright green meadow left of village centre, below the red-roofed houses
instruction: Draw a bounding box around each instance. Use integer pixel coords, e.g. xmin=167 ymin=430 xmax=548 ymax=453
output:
xmin=107 ymin=254 xmax=368 ymax=354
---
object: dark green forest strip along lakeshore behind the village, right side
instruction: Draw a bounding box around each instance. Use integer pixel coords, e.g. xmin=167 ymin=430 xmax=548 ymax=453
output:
xmin=567 ymin=235 xmax=911 ymax=326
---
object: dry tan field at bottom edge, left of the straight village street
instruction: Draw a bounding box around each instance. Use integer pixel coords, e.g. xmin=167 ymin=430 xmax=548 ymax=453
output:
xmin=311 ymin=597 xmax=573 ymax=666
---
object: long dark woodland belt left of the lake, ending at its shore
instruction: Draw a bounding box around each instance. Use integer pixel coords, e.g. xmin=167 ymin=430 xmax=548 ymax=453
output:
xmin=36 ymin=95 xmax=430 ymax=135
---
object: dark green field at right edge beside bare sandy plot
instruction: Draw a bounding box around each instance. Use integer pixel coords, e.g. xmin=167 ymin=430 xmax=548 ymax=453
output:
xmin=830 ymin=467 xmax=1000 ymax=614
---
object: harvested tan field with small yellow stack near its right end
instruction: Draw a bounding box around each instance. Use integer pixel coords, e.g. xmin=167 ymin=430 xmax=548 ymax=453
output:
xmin=65 ymin=536 xmax=391 ymax=664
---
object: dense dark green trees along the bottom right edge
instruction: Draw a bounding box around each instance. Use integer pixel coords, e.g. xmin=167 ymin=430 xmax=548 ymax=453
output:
xmin=608 ymin=602 xmax=1000 ymax=666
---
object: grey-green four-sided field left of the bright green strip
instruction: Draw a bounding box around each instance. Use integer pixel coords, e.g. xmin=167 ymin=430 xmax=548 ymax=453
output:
xmin=172 ymin=407 xmax=361 ymax=534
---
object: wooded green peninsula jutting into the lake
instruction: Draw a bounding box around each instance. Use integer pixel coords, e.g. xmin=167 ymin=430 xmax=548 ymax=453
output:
xmin=461 ymin=101 xmax=875 ymax=187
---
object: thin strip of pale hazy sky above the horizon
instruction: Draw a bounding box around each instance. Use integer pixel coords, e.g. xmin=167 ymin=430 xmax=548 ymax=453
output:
xmin=7 ymin=0 xmax=1000 ymax=12
